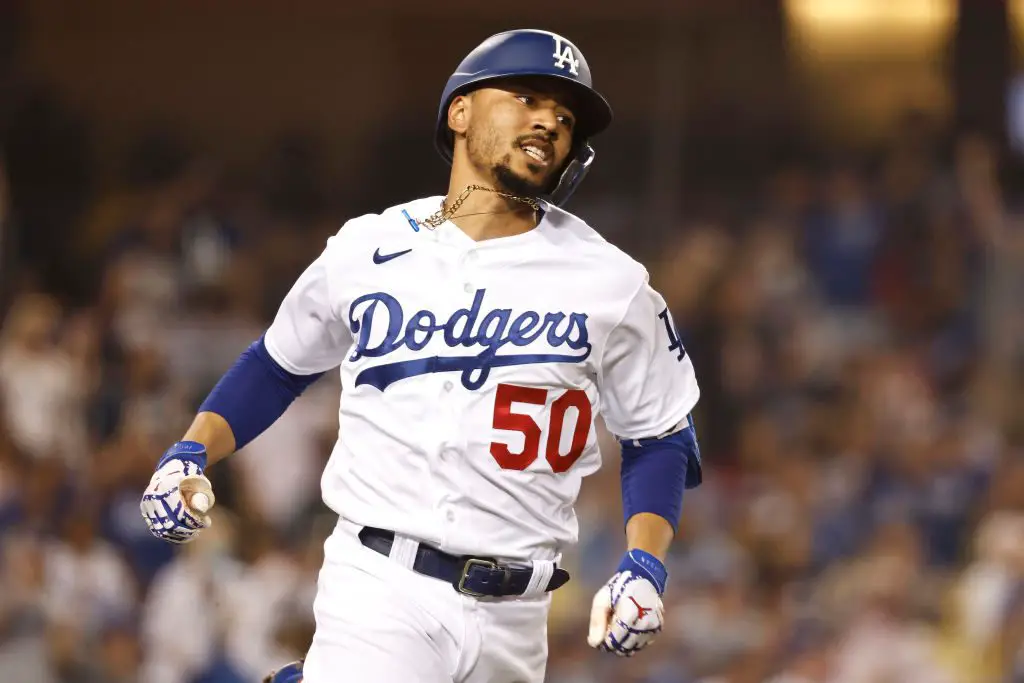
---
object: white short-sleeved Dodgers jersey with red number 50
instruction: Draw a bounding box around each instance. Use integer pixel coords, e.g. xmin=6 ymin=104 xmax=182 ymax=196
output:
xmin=260 ymin=197 xmax=698 ymax=560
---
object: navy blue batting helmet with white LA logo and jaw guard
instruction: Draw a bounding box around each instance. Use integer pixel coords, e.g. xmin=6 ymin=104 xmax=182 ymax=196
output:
xmin=435 ymin=29 xmax=611 ymax=206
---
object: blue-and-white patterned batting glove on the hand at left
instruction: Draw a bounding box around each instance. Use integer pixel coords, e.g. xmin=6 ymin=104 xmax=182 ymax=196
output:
xmin=139 ymin=441 xmax=214 ymax=544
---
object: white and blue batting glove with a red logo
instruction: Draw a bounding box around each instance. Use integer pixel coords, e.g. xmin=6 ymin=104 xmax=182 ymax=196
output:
xmin=587 ymin=550 xmax=669 ymax=657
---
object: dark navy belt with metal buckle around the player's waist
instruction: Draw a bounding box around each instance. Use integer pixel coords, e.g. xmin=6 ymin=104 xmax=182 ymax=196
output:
xmin=359 ymin=526 xmax=569 ymax=597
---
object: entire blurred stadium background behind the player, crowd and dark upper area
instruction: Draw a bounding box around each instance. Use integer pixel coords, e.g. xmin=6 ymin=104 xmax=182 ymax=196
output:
xmin=0 ymin=0 xmax=1024 ymax=683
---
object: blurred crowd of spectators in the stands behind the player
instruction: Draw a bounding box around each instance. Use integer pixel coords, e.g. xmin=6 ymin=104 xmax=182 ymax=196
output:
xmin=0 ymin=102 xmax=1024 ymax=683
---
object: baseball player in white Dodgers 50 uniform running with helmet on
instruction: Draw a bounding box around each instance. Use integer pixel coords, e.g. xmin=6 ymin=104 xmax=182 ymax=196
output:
xmin=141 ymin=30 xmax=700 ymax=683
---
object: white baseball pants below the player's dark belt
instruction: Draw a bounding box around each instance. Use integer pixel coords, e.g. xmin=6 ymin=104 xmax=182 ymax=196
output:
xmin=303 ymin=520 xmax=551 ymax=683
